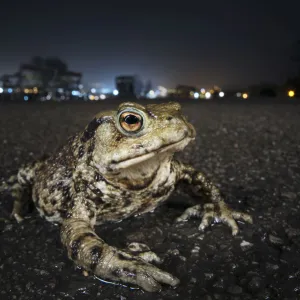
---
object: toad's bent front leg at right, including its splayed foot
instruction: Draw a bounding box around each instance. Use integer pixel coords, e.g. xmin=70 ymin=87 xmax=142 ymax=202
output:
xmin=175 ymin=162 xmax=252 ymax=235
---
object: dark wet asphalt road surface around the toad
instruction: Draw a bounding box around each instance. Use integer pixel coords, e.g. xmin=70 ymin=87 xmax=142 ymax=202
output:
xmin=0 ymin=99 xmax=300 ymax=300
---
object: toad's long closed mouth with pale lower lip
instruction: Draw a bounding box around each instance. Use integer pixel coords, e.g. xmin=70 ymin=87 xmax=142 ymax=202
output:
xmin=111 ymin=136 xmax=195 ymax=170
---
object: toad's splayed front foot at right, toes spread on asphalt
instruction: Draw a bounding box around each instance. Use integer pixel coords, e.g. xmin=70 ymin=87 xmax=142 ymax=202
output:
xmin=176 ymin=201 xmax=252 ymax=235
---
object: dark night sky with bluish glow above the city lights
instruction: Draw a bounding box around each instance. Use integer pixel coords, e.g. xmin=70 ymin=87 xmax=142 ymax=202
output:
xmin=0 ymin=0 xmax=300 ymax=87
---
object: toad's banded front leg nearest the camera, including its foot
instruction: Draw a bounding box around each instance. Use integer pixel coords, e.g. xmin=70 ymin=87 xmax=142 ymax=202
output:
xmin=61 ymin=218 xmax=179 ymax=292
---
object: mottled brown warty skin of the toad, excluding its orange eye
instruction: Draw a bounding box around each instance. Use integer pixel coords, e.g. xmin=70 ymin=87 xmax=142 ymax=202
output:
xmin=7 ymin=102 xmax=252 ymax=292
